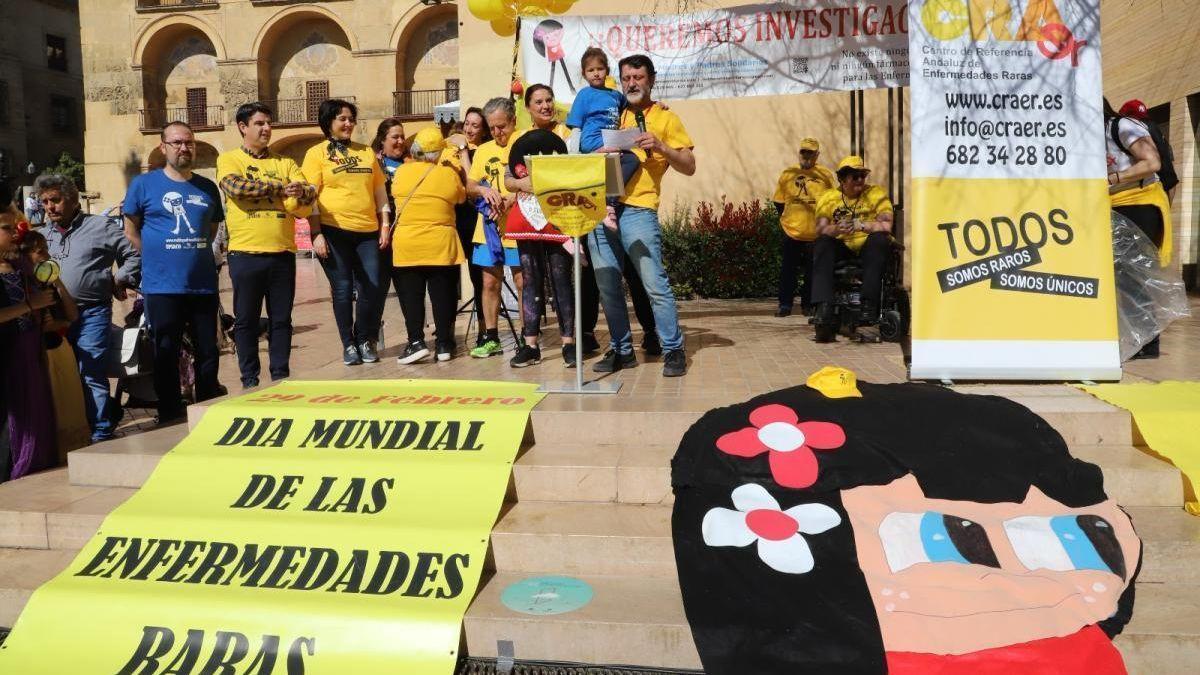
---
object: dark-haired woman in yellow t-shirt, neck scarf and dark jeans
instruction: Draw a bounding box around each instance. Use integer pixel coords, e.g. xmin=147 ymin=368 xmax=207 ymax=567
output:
xmin=300 ymin=98 xmax=391 ymax=365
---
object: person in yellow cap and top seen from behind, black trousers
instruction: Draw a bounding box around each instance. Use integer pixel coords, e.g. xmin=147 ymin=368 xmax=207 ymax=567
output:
xmin=391 ymin=127 xmax=467 ymax=364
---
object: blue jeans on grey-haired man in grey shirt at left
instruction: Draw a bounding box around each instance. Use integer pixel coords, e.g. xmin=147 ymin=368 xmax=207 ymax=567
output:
xmin=67 ymin=303 xmax=120 ymax=442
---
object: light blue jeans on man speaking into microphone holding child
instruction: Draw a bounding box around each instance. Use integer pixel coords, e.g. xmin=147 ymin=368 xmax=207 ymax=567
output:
xmin=588 ymin=204 xmax=683 ymax=354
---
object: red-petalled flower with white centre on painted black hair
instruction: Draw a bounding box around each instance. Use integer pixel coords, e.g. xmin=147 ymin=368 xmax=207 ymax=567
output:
xmin=716 ymin=404 xmax=846 ymax=488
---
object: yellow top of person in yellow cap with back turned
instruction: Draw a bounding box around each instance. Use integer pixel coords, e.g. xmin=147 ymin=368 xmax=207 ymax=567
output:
xmin=391 ymin=162 xmax=467 ymax=267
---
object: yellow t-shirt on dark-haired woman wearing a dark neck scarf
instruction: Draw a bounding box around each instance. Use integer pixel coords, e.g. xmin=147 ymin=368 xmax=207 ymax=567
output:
xmin=300 ymin=141 xmax=386 ymax=232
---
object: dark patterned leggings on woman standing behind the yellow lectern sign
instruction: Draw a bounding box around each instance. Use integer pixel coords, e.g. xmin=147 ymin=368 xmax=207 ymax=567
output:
xmin=517 ymin=241 xmax=575 ymax=338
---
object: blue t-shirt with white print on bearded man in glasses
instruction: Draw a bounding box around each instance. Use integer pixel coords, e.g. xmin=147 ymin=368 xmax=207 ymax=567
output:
xmin=121 ymin=169 xmax=224 ymax=293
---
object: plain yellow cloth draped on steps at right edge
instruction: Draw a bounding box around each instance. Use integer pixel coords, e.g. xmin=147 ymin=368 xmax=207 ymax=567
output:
xmin=1081 ymin=382 xmax=1200 ymax=515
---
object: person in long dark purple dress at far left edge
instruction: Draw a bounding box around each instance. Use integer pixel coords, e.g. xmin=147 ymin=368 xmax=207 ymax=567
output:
xmin=0 ymin=211 xmax=58 ymax=478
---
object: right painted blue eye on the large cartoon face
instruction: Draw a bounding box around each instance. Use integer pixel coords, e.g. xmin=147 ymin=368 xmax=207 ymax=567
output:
xmin=1004 ymin=515 xmax=1126 ymax=579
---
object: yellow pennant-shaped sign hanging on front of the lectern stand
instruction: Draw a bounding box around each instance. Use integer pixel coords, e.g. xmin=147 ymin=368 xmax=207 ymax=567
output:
xmin=529 ymin=155 xmax=606 ymax=237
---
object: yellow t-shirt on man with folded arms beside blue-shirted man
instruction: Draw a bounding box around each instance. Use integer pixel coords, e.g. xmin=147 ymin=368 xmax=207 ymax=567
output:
xmin=217 ymin=148 xmax=310 ymax=253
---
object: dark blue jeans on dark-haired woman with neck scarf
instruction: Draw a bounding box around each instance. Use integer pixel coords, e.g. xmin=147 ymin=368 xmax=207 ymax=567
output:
xmin=320 ymin=226 xmax=390 ymax=350
